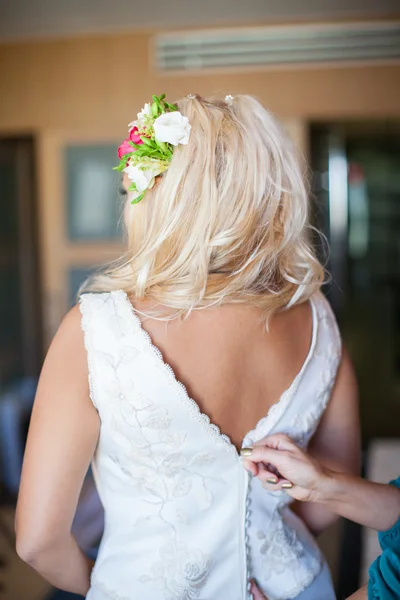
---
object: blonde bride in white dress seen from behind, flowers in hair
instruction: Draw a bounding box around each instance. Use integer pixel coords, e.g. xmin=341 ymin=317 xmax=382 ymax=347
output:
xmin=16 ymin=95 xmax=359 ymax=600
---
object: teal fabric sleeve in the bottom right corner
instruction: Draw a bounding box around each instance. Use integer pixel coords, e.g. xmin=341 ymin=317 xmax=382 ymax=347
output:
xmin=368 ymin=477 xmax=400 ymax=600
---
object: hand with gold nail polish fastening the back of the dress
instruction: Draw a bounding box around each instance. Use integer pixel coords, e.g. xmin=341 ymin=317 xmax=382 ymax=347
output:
xmin=242 ymin=434 xmax=329 ymax=502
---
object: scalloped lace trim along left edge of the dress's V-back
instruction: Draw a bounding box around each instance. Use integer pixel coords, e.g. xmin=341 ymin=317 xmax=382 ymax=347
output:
xmin=115 ymin=290 xmax=237 ymax=455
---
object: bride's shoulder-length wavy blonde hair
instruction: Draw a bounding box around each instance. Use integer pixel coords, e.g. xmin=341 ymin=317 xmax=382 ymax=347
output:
xmin=80 ymin=95 xmax=324 ymax=319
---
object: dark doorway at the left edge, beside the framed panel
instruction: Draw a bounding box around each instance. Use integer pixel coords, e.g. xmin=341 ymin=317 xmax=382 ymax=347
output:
xmin=0 ymin=138 xmax=43 ymax=390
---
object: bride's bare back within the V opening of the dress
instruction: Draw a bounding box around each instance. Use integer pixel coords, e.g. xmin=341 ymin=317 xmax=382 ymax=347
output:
xmin=135 ymin=302 xmax=312 ymax=448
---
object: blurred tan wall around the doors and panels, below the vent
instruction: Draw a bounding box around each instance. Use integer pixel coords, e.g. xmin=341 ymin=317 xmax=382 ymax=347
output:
xmin=0 ymin=25 xmax=400 ymax=338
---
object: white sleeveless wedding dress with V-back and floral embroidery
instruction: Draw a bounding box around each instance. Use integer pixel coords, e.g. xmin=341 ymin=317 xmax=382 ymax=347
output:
xmin=80 ymin=291 xmax=341 ymax=600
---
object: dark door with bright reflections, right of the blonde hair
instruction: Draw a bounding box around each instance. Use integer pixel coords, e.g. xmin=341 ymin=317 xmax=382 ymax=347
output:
xmin=311 ymin=121 xmax=400 ymax=439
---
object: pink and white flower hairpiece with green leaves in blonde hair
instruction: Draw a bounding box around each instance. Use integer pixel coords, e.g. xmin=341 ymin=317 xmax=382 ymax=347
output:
xmin=115 ymin=94 xmax=191 ymax=204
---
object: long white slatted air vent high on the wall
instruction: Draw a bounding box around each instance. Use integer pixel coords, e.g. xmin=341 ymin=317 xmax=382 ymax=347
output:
xmin=155 ymin=21 xmax=400 ymax=72
